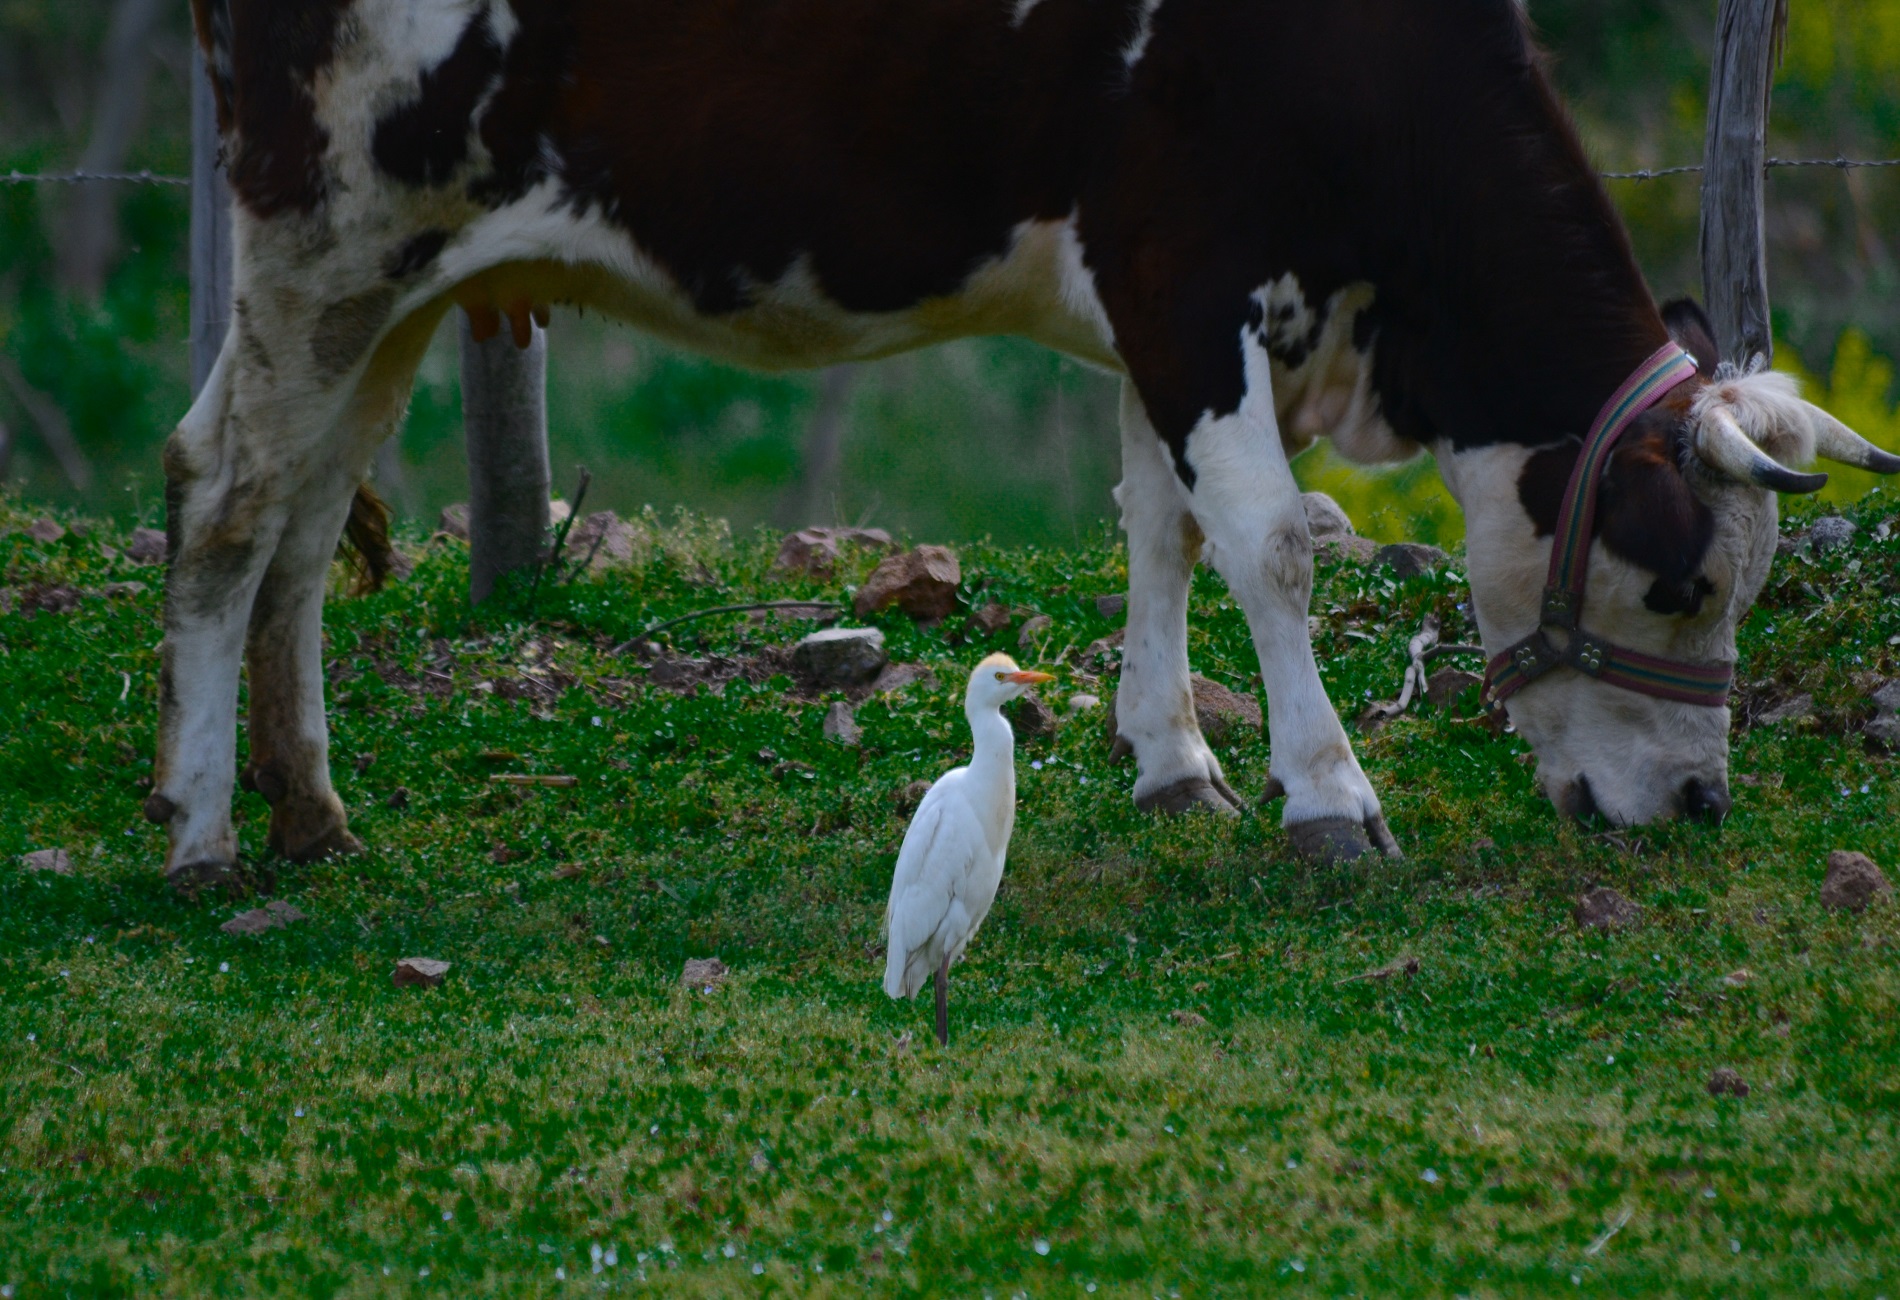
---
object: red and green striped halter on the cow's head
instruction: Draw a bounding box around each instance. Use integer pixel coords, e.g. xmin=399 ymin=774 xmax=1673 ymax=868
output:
xmin=1484 ymin=342 xmax=1735 ymax=713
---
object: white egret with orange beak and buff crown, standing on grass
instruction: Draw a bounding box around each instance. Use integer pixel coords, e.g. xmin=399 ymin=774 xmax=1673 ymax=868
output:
xmin=884 ymin=654 xmax=1055 ymax=1043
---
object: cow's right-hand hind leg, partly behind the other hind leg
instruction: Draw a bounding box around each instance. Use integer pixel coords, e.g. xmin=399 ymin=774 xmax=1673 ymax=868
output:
xmin=239 ymin=310 xmax=441 ymax=863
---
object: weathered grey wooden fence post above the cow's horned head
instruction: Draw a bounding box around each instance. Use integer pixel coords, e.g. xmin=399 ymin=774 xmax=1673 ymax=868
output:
xmin=1702 ymin=0 xmax=1788 ymax=367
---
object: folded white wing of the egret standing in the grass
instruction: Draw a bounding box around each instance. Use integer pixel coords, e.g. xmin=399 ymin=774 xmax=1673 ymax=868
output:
xmin=884 ymin=774 xmax=988 ymax=998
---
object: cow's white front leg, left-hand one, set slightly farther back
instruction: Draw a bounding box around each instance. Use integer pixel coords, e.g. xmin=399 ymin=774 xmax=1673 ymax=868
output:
xmin=1115 ymin=382 xmax=1241 ymax=817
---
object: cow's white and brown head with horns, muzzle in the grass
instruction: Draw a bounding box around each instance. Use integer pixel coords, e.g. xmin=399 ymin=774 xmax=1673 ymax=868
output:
xmin=1440 ymin=302 xmax=1900 ymax=825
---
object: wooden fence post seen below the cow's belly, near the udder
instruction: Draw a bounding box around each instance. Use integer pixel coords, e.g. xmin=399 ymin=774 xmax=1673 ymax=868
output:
xmin=454 ymin=312 xmax=551 ymax=604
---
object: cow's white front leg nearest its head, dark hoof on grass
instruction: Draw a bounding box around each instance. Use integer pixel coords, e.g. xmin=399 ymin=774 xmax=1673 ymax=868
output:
xmin=1186 ymin=357 xmax=1398 ymax=861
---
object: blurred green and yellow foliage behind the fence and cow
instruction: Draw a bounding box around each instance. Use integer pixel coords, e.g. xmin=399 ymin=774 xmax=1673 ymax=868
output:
xmin=0 ymin=0 xmax=1900 ymax=544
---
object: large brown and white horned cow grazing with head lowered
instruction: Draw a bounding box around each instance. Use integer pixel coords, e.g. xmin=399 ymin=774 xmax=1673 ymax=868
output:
xmin=146 ymin=0 xmax=1900 ymax=888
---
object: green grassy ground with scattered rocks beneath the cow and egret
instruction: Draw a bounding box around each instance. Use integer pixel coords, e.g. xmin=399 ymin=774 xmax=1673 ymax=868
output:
xmin=0 ymin=496 xmax=1900 ymax=1298
